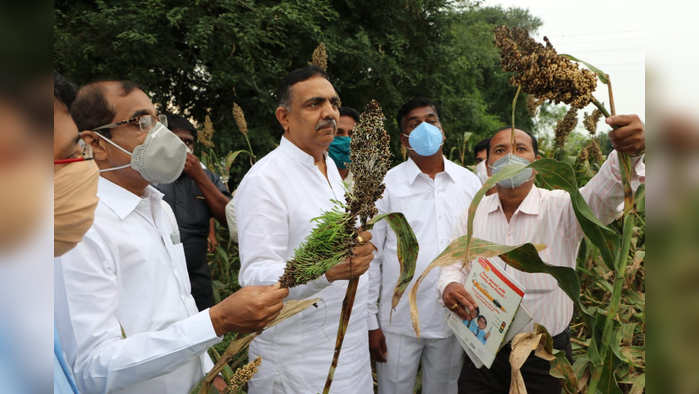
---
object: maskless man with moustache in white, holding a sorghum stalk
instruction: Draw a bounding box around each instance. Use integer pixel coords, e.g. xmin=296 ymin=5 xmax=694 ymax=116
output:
xmin=233 ymin=66 xmax=374 ymax=394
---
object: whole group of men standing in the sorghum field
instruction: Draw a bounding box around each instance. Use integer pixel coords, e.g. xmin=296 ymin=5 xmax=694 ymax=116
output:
xmin=54 ymin=66 xmax=645 ymax=394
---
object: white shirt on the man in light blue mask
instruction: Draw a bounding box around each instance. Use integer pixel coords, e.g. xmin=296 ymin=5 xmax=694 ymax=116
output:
xmin=368 ymin=158 xmax=481 ymax=338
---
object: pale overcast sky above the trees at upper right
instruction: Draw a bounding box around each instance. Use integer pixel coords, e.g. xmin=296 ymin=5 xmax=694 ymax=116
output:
xmin=484 ymin=0 xmax=645 ymax=119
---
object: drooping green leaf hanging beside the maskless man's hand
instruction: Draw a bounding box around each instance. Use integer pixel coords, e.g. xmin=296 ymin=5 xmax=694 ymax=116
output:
xmin=371 ymin=212 xmax=419 ymax=308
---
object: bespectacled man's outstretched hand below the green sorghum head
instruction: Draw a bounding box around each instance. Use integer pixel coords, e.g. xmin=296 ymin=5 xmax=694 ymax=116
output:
xmin=209 ymin=284 xmax=289 ymax=336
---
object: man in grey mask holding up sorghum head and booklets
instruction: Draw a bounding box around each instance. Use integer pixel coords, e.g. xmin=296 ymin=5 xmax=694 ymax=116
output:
xmin=439 ymin=115 xmax=645 ymax=393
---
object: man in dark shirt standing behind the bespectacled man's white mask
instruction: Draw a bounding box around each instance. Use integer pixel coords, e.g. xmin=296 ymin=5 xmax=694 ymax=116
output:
xmin=156 ymin=114 xmax=230 ymax=311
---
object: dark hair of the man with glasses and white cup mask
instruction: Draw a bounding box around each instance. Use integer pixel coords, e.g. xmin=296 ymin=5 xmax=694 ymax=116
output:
xmin=70 ymin=81 xmax=139 ymax=138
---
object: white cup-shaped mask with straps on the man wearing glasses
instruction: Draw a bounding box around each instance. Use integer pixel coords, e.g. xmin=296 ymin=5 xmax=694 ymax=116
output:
xmin=97 ymin=122 xmax=187 ymax=184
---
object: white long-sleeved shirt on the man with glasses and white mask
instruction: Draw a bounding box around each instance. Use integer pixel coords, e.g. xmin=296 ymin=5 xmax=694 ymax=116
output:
xmin=55 ymin=177 xmax=220 ymax=393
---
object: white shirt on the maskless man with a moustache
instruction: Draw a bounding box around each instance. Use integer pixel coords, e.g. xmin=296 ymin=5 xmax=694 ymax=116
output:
xmin=233 ymin=137 xmax=372 ymax=394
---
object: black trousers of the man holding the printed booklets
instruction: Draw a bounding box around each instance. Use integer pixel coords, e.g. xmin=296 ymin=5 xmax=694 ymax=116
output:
xmin=459 ymin=329 xmax=573 ymax=394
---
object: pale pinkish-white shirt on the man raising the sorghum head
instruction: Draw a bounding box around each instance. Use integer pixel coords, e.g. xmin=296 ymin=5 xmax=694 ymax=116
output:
xmin=439 ymin=151 xmax=645 ymax=335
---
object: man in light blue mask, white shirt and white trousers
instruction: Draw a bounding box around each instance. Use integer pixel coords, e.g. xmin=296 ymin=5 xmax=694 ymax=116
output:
xmin=368 ymin=97 xmax=481 ymax=394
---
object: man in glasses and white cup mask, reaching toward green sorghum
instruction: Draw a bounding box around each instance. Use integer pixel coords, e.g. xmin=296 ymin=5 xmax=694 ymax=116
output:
xmin=55 ymin=81 xmax=288 ymax=393
